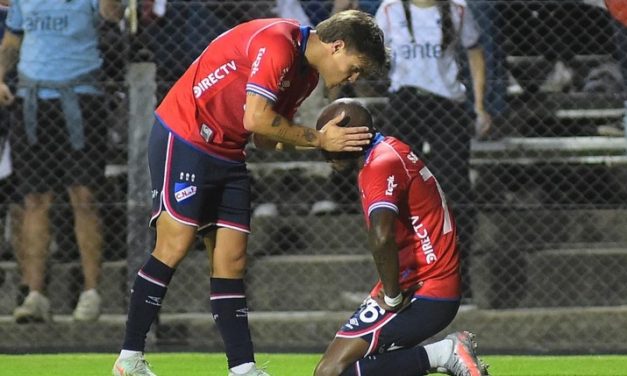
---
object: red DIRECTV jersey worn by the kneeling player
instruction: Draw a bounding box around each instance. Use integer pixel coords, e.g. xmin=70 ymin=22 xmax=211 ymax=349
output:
xmin=359 ymin=135 xmax=461 ymax=299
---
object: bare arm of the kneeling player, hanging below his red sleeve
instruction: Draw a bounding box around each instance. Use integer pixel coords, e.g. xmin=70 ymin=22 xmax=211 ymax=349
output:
xmin=368 ymin=208 xmax=401 ymax=298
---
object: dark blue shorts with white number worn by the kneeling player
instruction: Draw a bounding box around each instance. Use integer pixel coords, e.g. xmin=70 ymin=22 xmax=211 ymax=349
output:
xmin=335 ymin=297 xmax=459 ymax=357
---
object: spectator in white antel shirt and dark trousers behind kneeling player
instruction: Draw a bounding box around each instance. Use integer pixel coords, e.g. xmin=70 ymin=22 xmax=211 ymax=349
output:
xmin=376 ymin=0 xmax=491 ymax=298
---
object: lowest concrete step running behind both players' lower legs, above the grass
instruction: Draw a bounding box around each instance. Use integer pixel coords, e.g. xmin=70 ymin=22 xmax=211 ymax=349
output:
xmin=0 ymin=306 xmax=627 ymax=356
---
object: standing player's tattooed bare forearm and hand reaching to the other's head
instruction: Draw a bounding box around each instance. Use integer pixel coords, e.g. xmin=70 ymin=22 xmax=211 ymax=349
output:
xmin=244 ymin=93 xmax=371 ymax=151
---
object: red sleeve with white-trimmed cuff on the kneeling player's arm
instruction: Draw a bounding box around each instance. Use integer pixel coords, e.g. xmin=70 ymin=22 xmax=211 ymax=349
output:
xmin=361 ymin=159 xmax=407 ymax=218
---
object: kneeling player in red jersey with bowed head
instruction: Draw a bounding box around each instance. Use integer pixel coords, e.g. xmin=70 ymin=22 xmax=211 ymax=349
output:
xmin=315 ymin=99 xmax=487 ymax=376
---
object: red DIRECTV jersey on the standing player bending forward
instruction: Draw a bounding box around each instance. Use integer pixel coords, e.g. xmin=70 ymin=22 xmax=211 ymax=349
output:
xmin=155 ymin=18 xmax=318 ymax=161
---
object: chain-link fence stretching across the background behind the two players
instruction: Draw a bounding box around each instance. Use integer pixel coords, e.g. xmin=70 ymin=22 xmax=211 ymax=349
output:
xmin=0 ymin=0 xmax=627 ymax=353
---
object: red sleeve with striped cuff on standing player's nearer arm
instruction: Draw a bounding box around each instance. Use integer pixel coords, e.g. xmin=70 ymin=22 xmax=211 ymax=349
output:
xmin=246 ymin=28 xmax=296 ymax=102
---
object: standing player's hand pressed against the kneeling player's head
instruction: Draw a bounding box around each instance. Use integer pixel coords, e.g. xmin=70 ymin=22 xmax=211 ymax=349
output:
xmin=320 ymin=112 xmax=372 ymax=152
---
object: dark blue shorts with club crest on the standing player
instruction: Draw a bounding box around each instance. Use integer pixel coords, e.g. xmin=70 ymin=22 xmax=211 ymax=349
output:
xmin=148 ymin=121 xmax=250 ymax=232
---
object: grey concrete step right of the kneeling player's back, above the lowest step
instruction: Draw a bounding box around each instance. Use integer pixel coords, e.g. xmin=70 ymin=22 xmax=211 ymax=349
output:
xmin=471 ymin=243 xmax=627 ymax=309
